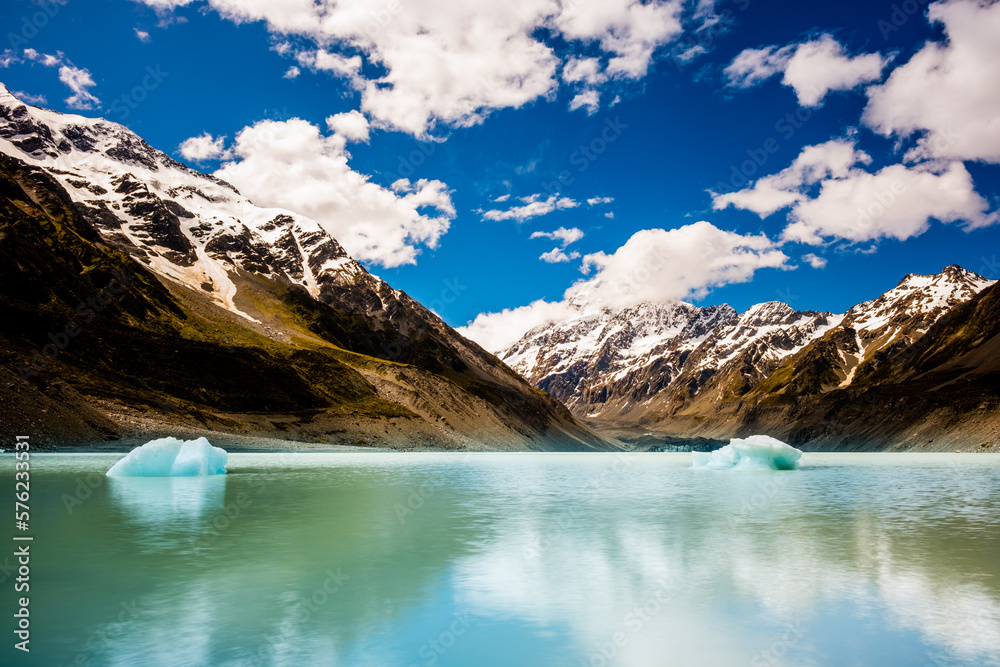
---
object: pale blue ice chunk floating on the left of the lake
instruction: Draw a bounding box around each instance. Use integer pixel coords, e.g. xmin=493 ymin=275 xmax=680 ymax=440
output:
xmin=108 ymin=438 xmax=229 ymax=477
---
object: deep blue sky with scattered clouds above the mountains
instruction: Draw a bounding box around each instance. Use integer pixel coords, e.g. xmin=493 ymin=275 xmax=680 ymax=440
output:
xmin=0 ymin=0 xmax=1000 ymax=352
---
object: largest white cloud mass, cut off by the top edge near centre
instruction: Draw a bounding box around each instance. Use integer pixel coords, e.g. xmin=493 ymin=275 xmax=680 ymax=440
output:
xmin=142 ymin=0 xmax=700 ymax=136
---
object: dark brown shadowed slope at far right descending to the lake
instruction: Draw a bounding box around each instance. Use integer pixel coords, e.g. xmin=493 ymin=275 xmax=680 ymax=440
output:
xmin=692 ymin=274 xmax=1000 ymax=451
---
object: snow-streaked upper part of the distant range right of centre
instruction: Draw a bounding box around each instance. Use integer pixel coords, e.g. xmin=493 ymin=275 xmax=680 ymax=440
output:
xmin=499 ymin=266 xmax=991 ymax=425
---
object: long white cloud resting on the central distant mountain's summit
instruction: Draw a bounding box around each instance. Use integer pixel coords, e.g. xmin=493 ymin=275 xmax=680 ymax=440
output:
xmin=459 ymin=221 xmax=791 ymax=352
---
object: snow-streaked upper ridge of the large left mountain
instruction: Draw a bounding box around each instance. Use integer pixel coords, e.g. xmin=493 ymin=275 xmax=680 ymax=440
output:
xmin=0 ymin=88 xmax=374 ymax=321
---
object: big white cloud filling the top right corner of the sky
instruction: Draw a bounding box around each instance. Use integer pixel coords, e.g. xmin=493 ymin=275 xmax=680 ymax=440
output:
xmin=864 ymin=1 xmax=1000 ymax=162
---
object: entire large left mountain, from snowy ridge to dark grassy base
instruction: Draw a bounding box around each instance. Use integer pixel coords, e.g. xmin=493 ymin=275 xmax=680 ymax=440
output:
xmin=0 ymin=86 xmax=611 ymax=449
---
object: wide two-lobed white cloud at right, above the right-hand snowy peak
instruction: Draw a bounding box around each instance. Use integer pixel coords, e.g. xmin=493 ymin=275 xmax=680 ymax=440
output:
xmin=713 ymin=139 xmax=997 ymax=245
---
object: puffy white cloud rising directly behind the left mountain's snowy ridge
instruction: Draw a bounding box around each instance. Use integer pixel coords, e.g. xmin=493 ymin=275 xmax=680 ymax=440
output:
xmin=215 ymin=118 xmax=455 ymax=268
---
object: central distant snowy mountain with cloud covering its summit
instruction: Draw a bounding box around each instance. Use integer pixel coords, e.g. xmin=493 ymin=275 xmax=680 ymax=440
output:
xmin=499 ymin=302 xmax=842 ymax=418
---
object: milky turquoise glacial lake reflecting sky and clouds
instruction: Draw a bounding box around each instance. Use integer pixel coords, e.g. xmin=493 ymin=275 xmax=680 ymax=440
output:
xmin=0 ymin=453 xmax=1000 ymax=667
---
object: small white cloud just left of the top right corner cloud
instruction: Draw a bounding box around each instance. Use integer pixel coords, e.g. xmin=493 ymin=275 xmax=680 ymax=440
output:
xmin=724 ymin=35 xmax=889 ymax=107
